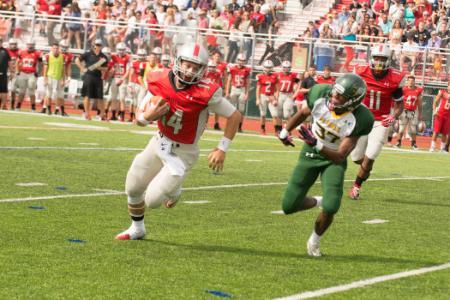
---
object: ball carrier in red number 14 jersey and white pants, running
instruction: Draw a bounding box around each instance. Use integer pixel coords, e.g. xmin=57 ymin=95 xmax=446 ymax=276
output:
xmin=116 ymin=43 xmax=241 ymax=240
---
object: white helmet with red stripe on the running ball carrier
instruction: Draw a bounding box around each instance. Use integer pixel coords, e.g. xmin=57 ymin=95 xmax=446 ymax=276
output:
xmin=173 ymin=43 xmax=208 ymax=85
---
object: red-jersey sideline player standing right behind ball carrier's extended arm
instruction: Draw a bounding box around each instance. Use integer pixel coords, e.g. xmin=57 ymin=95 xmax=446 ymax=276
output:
xmin=225 ymin=53 xmax=252 ymax=132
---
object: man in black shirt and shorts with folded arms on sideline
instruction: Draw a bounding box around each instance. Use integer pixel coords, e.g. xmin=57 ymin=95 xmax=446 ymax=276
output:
xmin=75 ymin=39 xmax=108 ymax=120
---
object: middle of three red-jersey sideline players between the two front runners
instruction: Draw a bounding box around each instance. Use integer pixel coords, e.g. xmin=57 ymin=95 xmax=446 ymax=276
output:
xmin=256 ymin=60 xmax=282 ymax=135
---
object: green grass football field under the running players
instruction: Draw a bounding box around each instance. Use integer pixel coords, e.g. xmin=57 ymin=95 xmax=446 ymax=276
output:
xmin=0 ymin=112 xmax=450 ymax=299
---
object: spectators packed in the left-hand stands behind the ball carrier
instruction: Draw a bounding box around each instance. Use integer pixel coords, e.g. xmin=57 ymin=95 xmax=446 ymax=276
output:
xmin=0 ymin=0 xmax=286 ymax=62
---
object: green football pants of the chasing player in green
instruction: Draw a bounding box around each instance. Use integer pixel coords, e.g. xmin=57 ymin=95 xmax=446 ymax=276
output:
xmin=283 ymin=151 xmax=347 ymax=214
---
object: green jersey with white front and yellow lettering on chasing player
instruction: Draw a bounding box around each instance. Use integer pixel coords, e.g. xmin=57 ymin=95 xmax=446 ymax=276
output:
xmin=307 ymin=84 xmax=374 ymax=150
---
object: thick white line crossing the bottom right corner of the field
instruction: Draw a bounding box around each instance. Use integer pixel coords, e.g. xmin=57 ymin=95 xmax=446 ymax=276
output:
xmin=276 ymin=263 xmax=450 ymax=300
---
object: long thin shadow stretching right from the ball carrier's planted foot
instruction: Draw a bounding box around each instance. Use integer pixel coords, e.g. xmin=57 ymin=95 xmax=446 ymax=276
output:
xmin=142 ymin=239 xmax=435 ymax=265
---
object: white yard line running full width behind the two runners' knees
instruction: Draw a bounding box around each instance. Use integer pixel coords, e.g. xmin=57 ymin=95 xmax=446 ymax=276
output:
xmin=0 ymin=176 xmax=450 ymax=203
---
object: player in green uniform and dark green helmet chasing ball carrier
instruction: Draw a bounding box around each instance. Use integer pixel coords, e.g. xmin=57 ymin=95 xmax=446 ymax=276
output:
xmin=279 ymin=74 xmax=374 ymax=256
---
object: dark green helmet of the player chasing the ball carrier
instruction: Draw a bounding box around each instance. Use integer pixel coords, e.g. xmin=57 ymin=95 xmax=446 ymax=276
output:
xmin=328 ymin=73 xmax=367 ymax=115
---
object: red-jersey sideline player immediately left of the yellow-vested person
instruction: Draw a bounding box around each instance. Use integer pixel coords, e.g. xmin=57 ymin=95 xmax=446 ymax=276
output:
xmin=16 ymin=40 xmax=42 ymax=112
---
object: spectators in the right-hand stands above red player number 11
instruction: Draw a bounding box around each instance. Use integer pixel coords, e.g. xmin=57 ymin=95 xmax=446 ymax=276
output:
xmin=303 ymin=0 xmax=450 ymax=77
